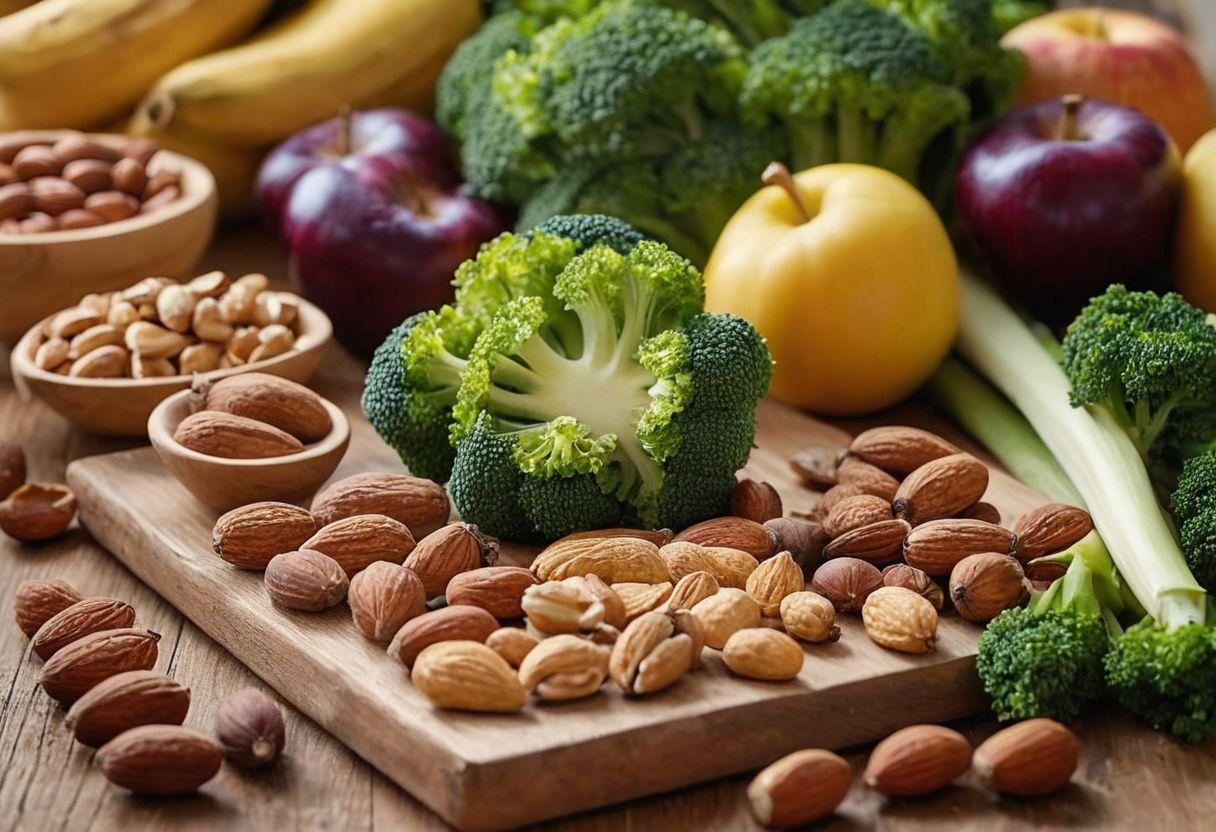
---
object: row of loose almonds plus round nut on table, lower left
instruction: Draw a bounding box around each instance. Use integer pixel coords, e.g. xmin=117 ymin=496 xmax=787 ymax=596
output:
xmin=13 ymin=571 xmax=286 ymax=794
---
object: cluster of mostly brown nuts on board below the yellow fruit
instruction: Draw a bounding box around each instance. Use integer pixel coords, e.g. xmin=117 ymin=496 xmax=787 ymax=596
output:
xmin=790 ymin=426 xmax=1093 ymax=653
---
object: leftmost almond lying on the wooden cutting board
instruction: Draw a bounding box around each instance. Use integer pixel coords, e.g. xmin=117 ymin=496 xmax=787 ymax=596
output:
xmin=212 ymin=502 xmax=316 ymax=569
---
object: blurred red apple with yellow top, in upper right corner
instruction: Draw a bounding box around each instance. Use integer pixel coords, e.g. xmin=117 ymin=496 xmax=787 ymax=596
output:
xmin=1002 ymin=9 xmax=1216 ymax=153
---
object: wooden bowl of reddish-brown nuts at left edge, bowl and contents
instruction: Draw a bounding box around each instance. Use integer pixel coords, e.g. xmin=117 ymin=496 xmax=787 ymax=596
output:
xmin=0 ymin=130 xmax=218 ymax=344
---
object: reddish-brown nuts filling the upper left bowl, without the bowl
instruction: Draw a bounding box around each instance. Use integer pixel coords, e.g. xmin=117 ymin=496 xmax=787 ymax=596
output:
xmin=0 ymin=131 xmax=181 ymax=234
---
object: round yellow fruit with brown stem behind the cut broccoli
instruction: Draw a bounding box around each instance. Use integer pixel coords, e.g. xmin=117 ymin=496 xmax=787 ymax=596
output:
xmin=705 ymin=164 xmax=958 ymax=415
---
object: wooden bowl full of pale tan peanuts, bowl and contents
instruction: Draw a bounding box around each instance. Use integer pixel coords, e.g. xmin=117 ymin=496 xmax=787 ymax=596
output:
xmin=11 ymin=271 xmax=333 ymax=437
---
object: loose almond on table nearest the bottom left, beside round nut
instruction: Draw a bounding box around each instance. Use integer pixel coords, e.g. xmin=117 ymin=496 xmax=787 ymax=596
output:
xmin=97 ymin=725 xmax=224 ymax=794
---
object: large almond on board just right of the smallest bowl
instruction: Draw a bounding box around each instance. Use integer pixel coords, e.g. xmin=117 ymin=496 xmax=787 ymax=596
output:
xmin=313 ymin=473 xmax=451 ymax=540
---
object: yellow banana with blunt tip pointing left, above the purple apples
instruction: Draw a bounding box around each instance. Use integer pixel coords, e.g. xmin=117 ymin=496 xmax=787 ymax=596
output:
xmin=135 ymin=0 xmax=480 ymax=147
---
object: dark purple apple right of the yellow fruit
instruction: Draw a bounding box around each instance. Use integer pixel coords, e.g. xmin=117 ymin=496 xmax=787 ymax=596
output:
xmin=955 ymin=96 xmax=1181 ymax=322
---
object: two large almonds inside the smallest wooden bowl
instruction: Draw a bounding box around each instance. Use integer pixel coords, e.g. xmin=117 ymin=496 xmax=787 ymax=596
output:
xmin=173 ymin=372 xmax=333 ymax=460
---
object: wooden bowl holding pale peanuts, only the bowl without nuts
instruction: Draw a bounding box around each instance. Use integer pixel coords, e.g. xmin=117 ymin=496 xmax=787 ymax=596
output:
xmin=12 ymin=298 xmax=333 ymax=437
